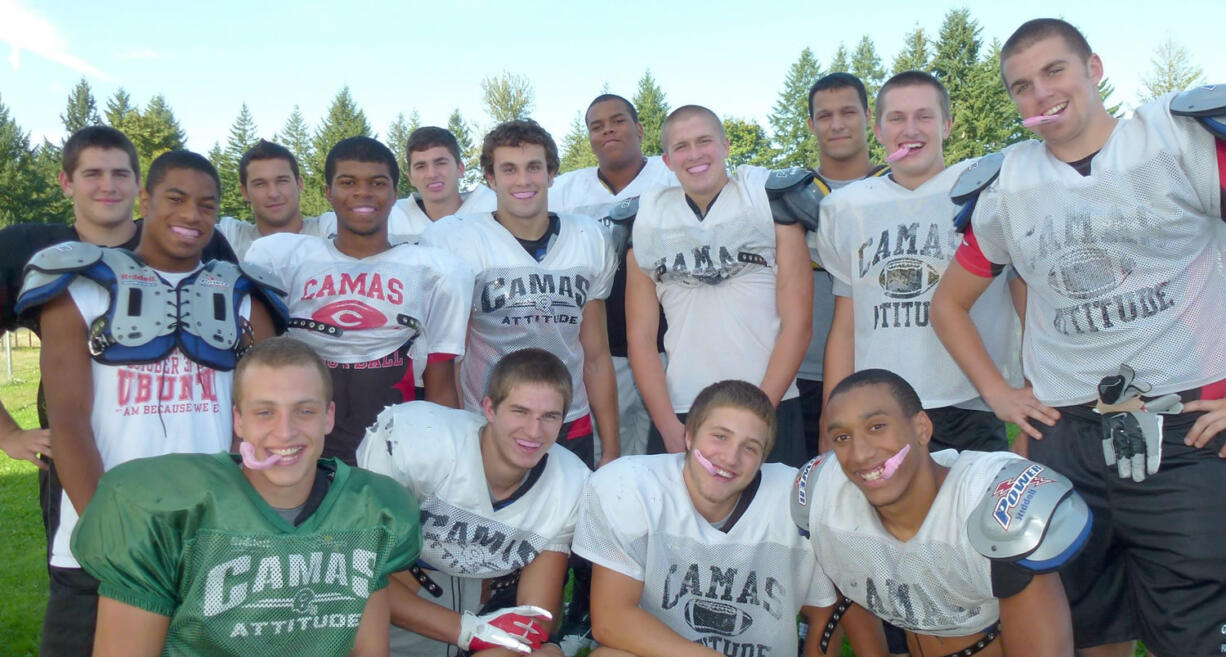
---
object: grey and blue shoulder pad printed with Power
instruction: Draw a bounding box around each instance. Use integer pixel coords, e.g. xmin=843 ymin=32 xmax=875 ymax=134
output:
xmin=966 ymin=458 xmax=1094 ymax=572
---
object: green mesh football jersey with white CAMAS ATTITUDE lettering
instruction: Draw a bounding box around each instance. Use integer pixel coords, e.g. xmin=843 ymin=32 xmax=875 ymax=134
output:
xmin=72 ymin=454 xmax=422 ymax=657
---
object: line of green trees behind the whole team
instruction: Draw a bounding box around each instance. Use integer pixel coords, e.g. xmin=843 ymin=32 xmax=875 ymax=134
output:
xmin=0 ymin=9 xmax=1203 ymax=227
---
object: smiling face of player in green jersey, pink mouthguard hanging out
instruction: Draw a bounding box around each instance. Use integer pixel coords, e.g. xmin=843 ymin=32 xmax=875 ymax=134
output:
xmin=234 ymin=363 xmax=336 ymax=509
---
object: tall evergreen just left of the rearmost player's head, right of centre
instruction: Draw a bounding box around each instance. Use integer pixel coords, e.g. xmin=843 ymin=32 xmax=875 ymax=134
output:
xmin=769 ymin=48 xmax=821 ymax=168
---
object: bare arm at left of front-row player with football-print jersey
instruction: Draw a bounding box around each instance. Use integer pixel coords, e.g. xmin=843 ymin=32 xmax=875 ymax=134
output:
xmin=592 ymin=564 xmax=720 ymax=657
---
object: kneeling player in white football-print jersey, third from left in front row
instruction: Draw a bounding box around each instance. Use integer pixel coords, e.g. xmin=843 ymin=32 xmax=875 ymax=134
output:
xmin=575 ymin=381 xmax=884 ymax=657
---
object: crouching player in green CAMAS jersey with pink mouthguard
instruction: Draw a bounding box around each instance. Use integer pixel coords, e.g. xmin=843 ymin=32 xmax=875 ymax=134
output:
xmin=72 ymin=337 xmax=422 ymax=657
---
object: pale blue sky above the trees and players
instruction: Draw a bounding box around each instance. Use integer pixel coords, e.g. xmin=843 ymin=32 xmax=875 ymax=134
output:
xmin=0 ymin=0 xmax=1226 ymax=152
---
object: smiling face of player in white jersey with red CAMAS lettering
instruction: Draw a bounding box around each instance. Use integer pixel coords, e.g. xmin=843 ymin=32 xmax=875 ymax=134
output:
xmin=326 ymin=159 xmax=396 ymax=235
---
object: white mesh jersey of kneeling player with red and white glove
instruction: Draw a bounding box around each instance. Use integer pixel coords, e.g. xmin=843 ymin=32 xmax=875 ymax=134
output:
xmin=358 ymin=402 xmax=590 ymax=656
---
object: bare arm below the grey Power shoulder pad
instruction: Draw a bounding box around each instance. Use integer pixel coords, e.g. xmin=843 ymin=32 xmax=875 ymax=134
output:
xmin=1000 ymin=572 xmax=1073 ymax=657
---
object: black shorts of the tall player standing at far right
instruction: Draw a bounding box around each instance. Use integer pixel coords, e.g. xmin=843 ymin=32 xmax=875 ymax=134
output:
xmin=1030 ymin=406 xmax=1226 ymax=656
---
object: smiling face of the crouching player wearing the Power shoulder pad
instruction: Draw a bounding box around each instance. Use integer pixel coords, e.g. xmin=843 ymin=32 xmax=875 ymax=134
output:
xmin=823 ymin=384 xmax=932 ymax=509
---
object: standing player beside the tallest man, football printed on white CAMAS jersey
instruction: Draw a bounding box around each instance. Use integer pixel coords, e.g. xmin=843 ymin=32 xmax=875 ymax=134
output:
xmin=809 ymin=71 xmax=1020 ymax=451
